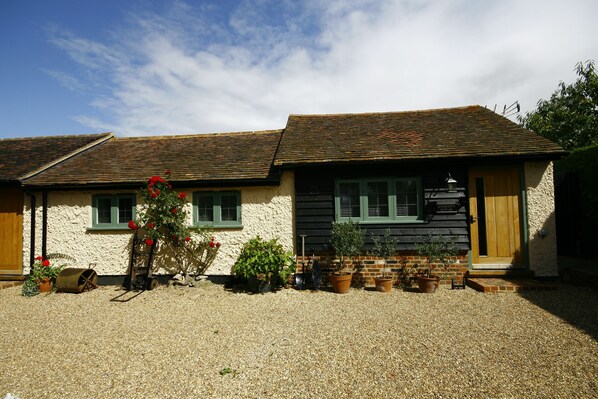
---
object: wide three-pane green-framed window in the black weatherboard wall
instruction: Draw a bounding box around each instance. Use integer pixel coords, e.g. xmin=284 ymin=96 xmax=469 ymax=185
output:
xmin=335 ymin=177 xmax=423 ymax=223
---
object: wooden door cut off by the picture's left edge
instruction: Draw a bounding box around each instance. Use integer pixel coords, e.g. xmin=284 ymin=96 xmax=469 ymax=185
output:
xmin=0 ymin=189 xmax=23 ymax=277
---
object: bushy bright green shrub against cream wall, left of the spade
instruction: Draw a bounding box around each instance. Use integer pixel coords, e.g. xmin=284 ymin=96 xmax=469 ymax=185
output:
xmin=232 ymin=236 xmax=296 ymax=285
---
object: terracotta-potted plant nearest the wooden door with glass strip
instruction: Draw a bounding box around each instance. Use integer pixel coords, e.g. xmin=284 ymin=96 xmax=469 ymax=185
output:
xmin=417 ymin=233 xmax=459 ymax=293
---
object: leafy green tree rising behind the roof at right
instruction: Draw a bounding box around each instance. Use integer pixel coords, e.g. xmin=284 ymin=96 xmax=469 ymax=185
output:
xmin=518 ymin=61 xmax=598 ymax=150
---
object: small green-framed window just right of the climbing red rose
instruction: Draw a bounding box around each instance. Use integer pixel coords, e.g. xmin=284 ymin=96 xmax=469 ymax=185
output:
xmin=193 ymin=191 xmax=241 ymax=227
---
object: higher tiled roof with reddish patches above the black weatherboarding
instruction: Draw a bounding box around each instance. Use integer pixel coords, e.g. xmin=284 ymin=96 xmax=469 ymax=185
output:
xmin=274 ymin=106 xmax=564 ymax=166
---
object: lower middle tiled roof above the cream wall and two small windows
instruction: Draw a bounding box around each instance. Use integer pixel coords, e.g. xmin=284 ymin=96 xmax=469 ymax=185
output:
xmin=25 ymin=130 xmax=282 ymax=186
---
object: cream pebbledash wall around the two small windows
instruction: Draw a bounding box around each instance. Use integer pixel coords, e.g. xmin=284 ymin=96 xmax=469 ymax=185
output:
xmin=23 ymin=171 xmax=294 ymax=275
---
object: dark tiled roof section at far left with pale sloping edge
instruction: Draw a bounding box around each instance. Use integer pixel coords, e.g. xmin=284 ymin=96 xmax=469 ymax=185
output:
xmin=0 ymin=133 xmax=112 ymax=182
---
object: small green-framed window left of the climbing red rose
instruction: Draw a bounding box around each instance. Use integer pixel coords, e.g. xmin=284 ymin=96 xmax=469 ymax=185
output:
xmin=92 ymin=194 xmax=135 ymax=229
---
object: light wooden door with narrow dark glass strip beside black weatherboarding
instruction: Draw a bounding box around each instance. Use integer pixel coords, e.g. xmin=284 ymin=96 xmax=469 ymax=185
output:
xmin=469 ymin=167 xmax=524 ymax=269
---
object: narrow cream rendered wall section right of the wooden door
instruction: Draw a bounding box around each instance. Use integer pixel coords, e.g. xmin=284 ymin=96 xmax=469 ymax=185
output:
xmin=525 ymin=161 xmax=558 ymax=277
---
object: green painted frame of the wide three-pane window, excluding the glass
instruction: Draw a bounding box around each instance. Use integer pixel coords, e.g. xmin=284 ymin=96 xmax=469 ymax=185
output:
xmin=334 ymin=177 xmax=424 ymax=224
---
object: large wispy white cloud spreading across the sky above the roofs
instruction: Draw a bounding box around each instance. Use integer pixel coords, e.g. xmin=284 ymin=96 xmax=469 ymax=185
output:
xmin=52 ymin=0 xmax=598 ymax=135
